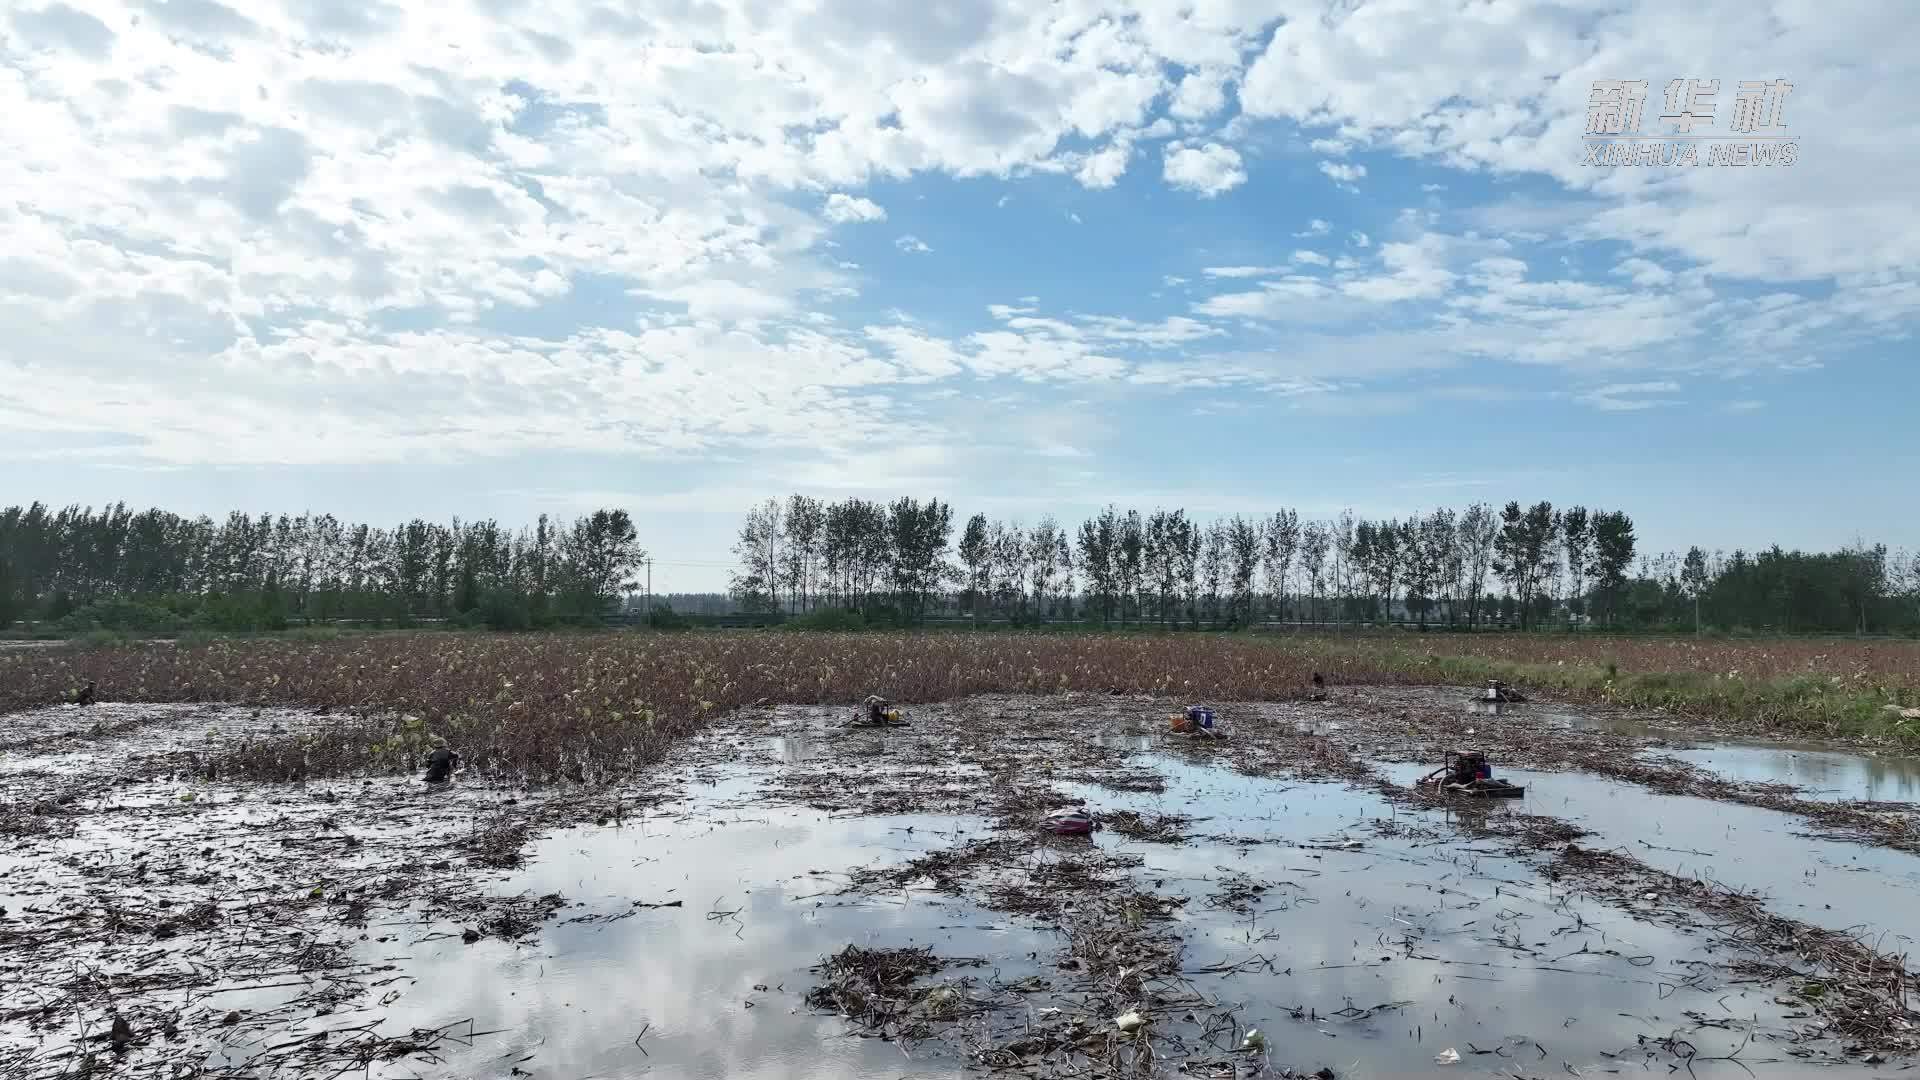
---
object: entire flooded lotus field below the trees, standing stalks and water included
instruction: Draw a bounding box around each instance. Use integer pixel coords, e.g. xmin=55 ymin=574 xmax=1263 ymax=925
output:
xmin=0 ymin=634 xmax=1920 ymax=1080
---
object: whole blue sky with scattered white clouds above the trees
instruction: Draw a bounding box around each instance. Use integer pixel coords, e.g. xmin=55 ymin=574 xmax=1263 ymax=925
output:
xmin=0 ymin=0 xmax=1920 ymax=592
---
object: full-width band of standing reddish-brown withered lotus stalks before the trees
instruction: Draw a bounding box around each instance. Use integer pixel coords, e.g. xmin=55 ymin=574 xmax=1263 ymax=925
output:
xmin=0 ymin=632 xmax=1920 ymax=780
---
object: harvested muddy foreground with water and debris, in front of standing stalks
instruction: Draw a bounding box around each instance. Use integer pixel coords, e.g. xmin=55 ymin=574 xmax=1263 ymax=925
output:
xmin=0 ymin=688 xmax=1920 ymax=1080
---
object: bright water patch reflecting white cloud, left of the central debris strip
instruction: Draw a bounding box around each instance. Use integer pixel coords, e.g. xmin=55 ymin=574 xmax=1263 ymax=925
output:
xmin=337 ymin=780 xmax=1050 ymax=1080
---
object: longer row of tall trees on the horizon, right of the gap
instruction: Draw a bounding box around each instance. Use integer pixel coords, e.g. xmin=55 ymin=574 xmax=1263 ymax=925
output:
xmin=732 ymin=496 xmax=1920 ymax=632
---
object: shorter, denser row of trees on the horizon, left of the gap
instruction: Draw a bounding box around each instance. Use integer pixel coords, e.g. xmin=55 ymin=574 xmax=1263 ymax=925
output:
xmin=0 ymin=503 xmax=645 ymax=630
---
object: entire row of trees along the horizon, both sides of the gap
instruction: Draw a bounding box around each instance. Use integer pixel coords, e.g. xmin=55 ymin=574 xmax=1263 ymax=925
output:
xmin=0 ymin=496 xmax=1920 ymax=632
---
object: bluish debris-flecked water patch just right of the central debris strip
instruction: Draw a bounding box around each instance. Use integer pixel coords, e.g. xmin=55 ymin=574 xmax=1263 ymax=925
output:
xmin=1059 ymin=763 xmax=1804 ymax=1076
